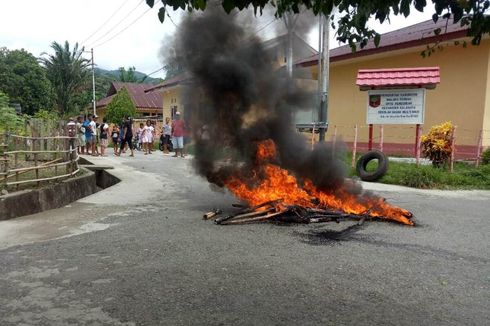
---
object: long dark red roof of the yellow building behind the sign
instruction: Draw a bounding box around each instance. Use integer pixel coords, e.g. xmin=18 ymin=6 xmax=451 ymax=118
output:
xmin=295 ymin=19 xmax=468 ymax=67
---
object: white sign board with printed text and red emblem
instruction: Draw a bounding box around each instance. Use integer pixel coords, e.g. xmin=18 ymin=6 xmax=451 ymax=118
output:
xmin=366 ymin=88 xmax=425 ymax=125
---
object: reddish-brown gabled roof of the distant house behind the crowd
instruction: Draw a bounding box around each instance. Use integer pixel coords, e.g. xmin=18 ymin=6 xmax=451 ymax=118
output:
xmin=97 ymin=82 xmax=163 ymax=109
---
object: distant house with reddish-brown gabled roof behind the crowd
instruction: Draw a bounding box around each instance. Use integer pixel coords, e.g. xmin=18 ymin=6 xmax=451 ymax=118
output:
xmin=96 ymin=82 xmax=163 ymax=121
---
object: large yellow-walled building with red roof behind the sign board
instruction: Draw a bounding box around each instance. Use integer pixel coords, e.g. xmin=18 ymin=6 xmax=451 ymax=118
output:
xmin=295 ymin=20 xmax=490 ymax=158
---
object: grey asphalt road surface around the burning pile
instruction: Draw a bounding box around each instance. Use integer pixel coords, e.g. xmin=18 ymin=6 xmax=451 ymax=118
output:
xmin=0 ymin=153 xmax=490 ymax=326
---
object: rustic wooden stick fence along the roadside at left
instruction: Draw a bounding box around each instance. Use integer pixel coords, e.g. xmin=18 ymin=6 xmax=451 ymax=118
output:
xmin=0 ymin=133 xmax=80 ymax=190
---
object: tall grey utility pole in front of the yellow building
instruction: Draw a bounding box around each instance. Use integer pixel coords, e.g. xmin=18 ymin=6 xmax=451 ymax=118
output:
xmin=318 ymin=14 xmax=330 ymax=141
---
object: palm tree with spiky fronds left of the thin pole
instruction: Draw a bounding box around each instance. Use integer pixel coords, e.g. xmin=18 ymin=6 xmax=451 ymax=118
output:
xmin=40 ymin=41 xmax=90 ymax=115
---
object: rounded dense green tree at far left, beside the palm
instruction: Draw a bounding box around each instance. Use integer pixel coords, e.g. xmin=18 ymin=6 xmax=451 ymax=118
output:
xmin=0 ymin=48 xmax=54 ymax=114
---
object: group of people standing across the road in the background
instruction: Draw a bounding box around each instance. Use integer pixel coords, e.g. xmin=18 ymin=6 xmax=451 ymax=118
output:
xmin=72 ymin=112 xmax=185 ymax=157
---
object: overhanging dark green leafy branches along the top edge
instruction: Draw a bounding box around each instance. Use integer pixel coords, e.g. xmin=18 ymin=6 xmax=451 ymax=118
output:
xmin=146 ymin=0 xmax=490 ymax=49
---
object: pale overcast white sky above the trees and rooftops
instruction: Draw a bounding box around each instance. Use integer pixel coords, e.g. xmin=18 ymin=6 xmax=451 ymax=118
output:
xmin=0 ymin=0 xmax=432 ymax=77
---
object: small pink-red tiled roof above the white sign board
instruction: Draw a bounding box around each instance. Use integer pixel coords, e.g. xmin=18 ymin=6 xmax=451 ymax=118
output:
xmin=356 ymin=67 xmax=441 ymax=89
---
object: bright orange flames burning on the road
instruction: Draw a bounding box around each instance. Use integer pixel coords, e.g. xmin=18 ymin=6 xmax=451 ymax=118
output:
xmin=226 ymin=139 xmax=414 ymax=225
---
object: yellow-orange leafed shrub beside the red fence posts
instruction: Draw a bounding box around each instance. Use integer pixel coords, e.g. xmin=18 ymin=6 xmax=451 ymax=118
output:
xmin=421 ymin=122 xmax=453 ymax=167
